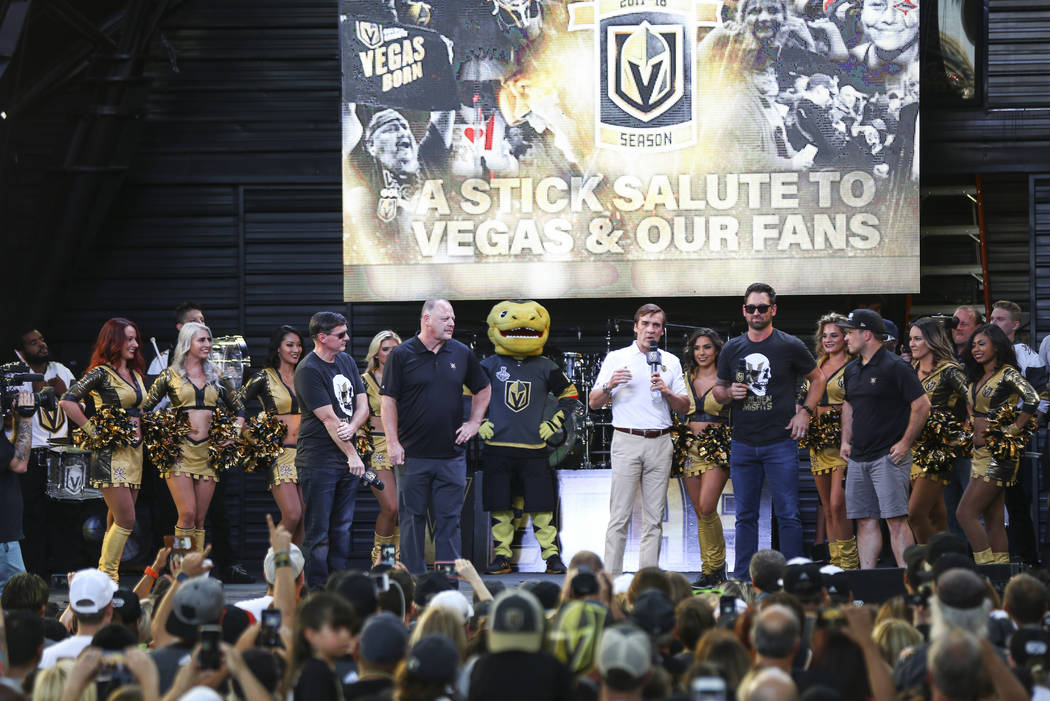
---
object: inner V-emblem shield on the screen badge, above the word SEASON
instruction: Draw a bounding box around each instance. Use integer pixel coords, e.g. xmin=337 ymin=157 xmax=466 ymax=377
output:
xmin=607 ymin=20 xmax=685 ymax=123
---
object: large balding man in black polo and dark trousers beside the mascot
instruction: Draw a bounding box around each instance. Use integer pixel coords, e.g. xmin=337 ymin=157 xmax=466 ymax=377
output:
xmin=379 ymin=299 xmax=491 ymax=574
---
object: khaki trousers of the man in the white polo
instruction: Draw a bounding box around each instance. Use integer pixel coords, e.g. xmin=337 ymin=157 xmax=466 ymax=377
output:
xmin=605 ymin=431 xmax=673 ymax=575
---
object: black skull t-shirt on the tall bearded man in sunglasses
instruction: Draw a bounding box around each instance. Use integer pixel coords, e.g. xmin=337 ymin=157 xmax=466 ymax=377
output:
xmin=718 ymin=328 xmax=817 ymax=445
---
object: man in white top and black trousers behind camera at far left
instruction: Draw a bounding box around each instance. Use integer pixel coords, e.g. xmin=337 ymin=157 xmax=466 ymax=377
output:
xmin=12 ymin=328 xmax=78 ymax=579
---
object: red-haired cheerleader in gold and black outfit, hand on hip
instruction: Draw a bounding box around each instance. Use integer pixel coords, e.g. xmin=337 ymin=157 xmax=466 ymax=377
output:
xmin=60 ymin=317 xmax=146 ymax=582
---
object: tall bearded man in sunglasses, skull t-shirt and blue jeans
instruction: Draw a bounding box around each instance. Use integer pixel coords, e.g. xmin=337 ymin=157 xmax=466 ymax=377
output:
xmin=714 ymin=282 xmax=824 ymax=579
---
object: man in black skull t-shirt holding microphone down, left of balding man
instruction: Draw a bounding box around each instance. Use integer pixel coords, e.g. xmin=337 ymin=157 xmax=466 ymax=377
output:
xmin=295 ymin=312 xmax=369 ymax=589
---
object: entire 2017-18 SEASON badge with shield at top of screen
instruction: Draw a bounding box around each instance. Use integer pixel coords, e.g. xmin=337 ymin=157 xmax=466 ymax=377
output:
xmin=595 ymin=0 xmax=696 ymax=152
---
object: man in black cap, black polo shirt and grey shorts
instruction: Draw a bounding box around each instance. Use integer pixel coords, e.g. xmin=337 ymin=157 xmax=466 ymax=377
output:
xmin=839 ymin=310 xmax=929 ymax=569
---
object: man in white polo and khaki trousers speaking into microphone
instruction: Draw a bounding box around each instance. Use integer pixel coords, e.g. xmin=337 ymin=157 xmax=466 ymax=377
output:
xmin=587 ymin=304 xmax=689 ymax=576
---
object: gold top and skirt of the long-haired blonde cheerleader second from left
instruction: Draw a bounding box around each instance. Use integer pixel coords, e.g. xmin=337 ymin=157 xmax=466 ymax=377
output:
xmin=142 ymin=367 xmax=245 ymax=482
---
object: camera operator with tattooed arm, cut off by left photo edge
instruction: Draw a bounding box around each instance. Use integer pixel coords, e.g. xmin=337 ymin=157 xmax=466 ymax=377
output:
xmin=0 ymin=391 xmax=34 ymax=592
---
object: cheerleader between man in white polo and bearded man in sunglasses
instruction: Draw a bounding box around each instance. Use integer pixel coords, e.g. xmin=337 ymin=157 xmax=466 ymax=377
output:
xmin=683 ymin=328 xmax=729 ymax=589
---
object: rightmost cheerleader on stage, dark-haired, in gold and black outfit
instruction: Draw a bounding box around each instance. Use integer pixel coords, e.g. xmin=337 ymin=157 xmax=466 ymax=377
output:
xmin=956 ymin=324 xmax=1040 ymax=565
